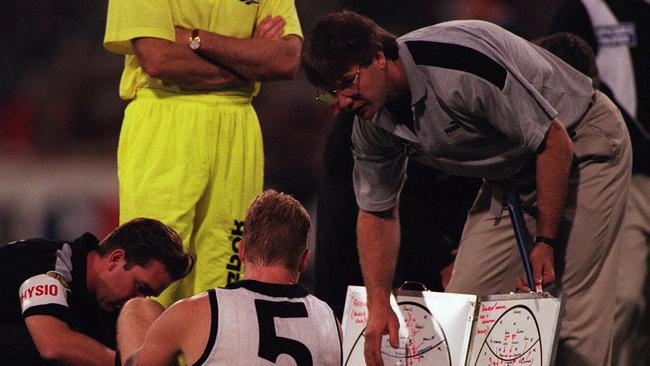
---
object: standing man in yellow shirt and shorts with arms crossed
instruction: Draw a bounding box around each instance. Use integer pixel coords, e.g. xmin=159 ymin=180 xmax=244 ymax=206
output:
xmin=104 ymin=0 xmax=302 ymax=306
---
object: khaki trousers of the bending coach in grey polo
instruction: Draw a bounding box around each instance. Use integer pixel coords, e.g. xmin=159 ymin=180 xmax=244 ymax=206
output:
xmin=447 ymin=92 xmax=631 ymax=366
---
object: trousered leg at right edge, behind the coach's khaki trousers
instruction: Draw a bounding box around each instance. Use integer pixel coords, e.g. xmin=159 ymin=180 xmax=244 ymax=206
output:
xmin=613 ymin=175 xmax=650 ymax=366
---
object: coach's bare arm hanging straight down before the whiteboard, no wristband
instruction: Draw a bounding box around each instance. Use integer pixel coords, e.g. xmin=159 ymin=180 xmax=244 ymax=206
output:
xmin=357 ymin=206 xmax=399 ymax=366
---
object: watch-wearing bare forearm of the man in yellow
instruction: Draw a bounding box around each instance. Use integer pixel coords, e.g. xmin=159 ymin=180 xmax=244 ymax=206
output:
xmin=176 ymin=17 xmax=302 ymax=81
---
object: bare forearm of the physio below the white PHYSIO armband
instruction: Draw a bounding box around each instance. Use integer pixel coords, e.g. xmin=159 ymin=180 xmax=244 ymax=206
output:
xmin=25 ymin=315 xmax=115 ymax=366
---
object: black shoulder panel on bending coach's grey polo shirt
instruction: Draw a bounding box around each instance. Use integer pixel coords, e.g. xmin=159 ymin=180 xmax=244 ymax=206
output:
xmin=406 ymin=41 xmax=508 ymax=90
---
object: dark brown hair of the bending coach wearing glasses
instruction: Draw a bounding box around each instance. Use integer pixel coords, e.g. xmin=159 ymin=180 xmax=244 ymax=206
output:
xmin=302 ymin=10 xmax=398 ymax=87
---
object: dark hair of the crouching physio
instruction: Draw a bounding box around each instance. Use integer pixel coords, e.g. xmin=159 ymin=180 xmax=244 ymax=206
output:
xmin=97 ymin=218 xmax=194 ymax=281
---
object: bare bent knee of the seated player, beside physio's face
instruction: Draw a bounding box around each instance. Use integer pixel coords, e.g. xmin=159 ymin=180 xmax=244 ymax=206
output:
xmin=117 ymin=297 xmax=165 ymax=365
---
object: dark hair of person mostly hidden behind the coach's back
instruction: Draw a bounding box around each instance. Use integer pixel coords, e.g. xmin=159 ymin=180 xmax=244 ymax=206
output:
xmin=533 ymin=32 xmax=599 ymax=89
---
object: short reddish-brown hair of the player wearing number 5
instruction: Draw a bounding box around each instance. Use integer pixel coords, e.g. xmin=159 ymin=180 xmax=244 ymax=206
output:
xmin=242 ymin=189 xmax=311 ymax=270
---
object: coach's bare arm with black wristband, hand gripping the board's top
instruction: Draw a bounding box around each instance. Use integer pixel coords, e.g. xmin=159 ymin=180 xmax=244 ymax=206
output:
xmin=518 ymin=118 xmax=573 ymax=287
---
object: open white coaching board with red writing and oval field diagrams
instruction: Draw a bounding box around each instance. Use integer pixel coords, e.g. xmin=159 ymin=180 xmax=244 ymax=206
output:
xmin=342 ymin=286 xmax=563 ymax=366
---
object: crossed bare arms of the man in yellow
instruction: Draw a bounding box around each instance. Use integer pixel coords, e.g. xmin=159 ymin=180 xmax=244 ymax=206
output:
xmin=133 ymin=17 xmax=302 ymax=90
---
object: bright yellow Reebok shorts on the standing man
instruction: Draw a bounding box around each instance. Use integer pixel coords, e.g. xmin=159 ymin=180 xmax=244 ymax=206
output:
xmin=117 ymin=89 xmax=264 ymax=307
